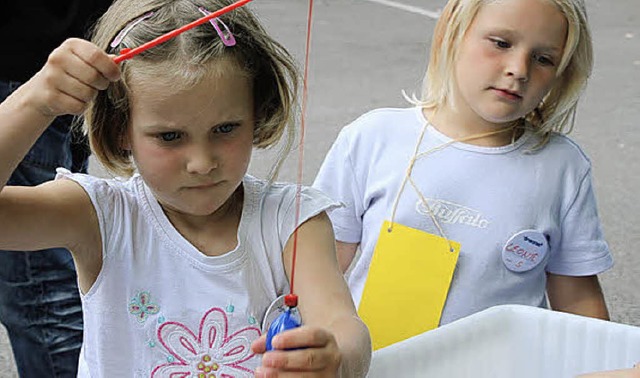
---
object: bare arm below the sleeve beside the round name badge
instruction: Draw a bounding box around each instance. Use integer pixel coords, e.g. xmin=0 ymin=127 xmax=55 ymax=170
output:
xmin=547 ymin=273 xmax=609 ymax=320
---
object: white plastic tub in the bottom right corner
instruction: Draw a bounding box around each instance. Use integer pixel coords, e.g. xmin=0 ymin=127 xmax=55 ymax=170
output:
xmin=369 ymin=305 xmax=640 ymax=378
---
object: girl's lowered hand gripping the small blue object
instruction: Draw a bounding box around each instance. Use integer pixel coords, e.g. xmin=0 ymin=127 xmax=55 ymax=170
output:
xmin=251 ymin=326 xmax=342 ymax=378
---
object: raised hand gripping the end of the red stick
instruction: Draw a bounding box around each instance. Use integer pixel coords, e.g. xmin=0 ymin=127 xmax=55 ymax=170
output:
xmin=22 ymin=38 xmax=120 ymax=117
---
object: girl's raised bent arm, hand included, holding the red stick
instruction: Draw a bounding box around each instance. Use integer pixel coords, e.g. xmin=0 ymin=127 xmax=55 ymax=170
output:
xmin=0 ymin=39 xmax=120 ymax=290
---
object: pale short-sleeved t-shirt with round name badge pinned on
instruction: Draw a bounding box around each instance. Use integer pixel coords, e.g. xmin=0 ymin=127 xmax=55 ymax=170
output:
xmin=314 ymin=107 xmax=613 ymax=325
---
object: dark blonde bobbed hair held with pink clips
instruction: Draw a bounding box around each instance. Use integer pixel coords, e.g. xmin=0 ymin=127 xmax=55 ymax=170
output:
xmin=85 ymin=0 xmax=298 ymax=178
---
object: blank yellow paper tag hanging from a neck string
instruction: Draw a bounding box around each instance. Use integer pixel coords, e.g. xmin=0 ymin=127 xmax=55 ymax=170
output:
xmin=358 ymin=221 xmax=460 ymax=350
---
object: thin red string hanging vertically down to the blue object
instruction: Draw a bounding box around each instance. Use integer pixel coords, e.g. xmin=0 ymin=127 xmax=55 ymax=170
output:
xmin=289 ymin=0 xmax=313 ymax=302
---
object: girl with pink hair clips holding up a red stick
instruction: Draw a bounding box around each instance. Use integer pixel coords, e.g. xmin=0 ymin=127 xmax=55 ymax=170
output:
xmin=0 ymin=0 xmax=371 ymax=377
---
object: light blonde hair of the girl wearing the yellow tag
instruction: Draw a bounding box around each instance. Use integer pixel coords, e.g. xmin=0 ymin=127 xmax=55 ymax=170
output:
xmin=413 ymin=0 xmax=593 ymax=147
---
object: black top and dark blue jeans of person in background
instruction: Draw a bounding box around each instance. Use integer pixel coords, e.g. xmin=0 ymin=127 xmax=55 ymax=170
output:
xmin=0 ymin=0 xmax=111 ymax=378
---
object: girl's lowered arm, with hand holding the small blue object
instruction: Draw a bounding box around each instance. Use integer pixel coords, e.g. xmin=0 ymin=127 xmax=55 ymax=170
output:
xmin=253 ymin=213 xmax=371 ymax=377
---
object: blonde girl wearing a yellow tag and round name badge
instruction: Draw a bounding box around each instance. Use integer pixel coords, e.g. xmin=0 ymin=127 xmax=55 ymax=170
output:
xmin=314 ymin=0 xmax=612 ymax=334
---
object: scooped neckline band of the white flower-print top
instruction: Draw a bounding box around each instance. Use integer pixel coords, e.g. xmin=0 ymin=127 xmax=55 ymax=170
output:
xmin=140 ymin=176 xmax=256 ymax=270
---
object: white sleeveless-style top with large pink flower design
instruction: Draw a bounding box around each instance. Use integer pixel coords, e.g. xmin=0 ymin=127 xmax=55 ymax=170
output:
xmin=58 ymin=171 xmax=335 ymax=378
